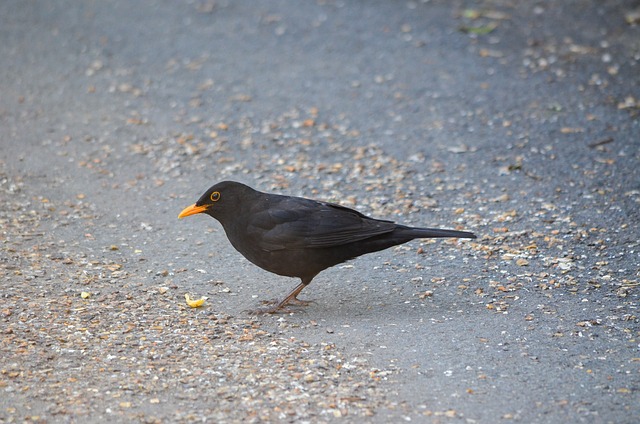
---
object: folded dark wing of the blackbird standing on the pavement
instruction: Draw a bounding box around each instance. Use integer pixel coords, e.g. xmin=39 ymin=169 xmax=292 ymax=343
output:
xmin=251 ymin=198 xmax=396 ymax=250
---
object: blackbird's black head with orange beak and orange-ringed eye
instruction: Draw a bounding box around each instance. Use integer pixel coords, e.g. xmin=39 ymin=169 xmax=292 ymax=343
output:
xmin=178 ymin=181 xmax=254 ymax=220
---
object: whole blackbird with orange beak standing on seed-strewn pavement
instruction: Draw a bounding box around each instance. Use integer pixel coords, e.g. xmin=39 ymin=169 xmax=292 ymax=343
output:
xmin=178 ymin=181 xmax=476 ymax=313
